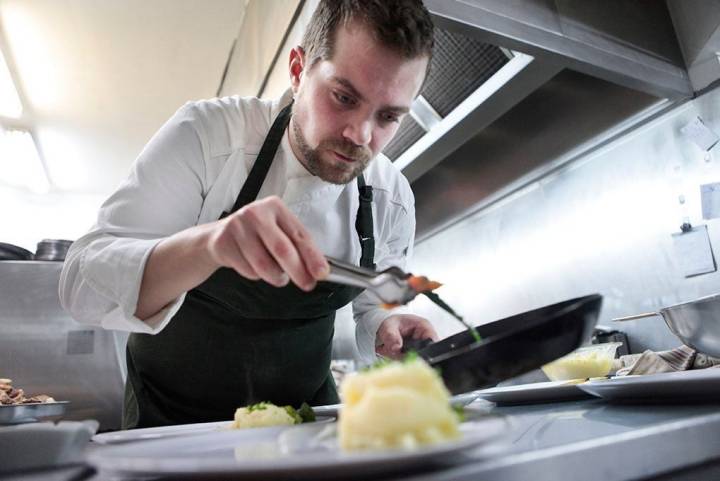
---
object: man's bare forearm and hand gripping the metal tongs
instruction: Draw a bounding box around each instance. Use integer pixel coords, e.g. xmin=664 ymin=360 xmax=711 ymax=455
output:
xmin=135 ymin=193 xmax=330 ymax=320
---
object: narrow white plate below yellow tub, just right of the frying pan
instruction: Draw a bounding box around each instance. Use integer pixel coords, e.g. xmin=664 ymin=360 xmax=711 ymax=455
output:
xmin=476 ymin=381 xmax=592 ymax=404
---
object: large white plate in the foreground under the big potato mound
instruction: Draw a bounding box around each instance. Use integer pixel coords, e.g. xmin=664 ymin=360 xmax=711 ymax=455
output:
xmin=88 ymin=416 xmax=509 ymax=479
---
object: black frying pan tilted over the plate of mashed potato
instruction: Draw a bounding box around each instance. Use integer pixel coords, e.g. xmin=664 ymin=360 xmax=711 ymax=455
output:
xmin=418 ymin=294 xmax=602 ymax=394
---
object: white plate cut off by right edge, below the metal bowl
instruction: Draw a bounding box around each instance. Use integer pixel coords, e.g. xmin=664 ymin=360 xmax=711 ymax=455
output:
xmin=578 ymin=368 xmax=720 ymax=401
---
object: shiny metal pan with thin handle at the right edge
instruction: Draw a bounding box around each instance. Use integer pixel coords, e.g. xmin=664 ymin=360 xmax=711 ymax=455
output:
xmin=613 ymin=294 xmax=720 ymax=357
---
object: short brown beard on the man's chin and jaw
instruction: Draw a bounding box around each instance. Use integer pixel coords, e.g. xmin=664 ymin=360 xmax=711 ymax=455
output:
xmin=291 ymin=115 xmax=372 ymax=185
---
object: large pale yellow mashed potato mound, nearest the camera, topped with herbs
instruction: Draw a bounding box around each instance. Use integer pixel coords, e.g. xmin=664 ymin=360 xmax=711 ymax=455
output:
xmin=338 ymin=356 xmax=460 ymax=451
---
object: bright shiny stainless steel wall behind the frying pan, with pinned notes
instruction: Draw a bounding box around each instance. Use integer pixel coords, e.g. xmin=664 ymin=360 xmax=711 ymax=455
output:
xmin=411 ymin=82 xmax=720 ymax=352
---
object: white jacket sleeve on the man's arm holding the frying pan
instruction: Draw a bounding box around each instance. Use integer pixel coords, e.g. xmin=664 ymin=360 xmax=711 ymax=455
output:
xmin=353 ymin=191 xmax=415 ymax=364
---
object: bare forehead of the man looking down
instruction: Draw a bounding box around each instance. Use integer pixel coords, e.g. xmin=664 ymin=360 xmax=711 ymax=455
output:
xmin=317 ymin=23 xmax=428 ymax=107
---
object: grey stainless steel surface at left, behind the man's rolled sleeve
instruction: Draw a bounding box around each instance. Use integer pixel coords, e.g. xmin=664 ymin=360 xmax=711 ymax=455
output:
xmin=0 ymin=261 xmax=127 ymax=430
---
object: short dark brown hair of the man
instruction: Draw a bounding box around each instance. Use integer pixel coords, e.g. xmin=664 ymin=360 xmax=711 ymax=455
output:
xmin=300 ymin=0 xmax=434 ymax=68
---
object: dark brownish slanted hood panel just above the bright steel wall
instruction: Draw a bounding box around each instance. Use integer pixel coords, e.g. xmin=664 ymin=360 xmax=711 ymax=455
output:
xmin=413 ymin=70 xmax=658 ymax=239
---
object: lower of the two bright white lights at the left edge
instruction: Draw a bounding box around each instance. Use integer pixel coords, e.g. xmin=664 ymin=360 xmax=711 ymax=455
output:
xmin=0 ymin=129 xmax=50 ymax=194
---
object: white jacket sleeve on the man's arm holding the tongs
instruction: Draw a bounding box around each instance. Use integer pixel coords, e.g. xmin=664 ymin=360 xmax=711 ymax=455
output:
xmin=59 ymin=104 xmax=207 ymax=334
